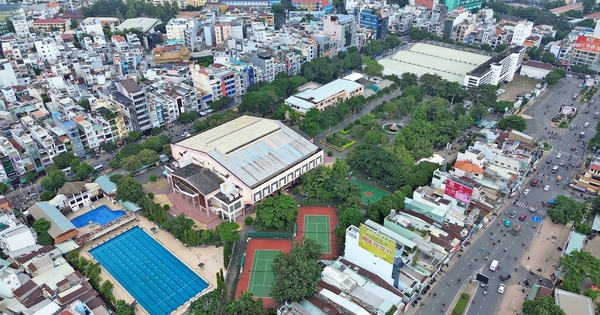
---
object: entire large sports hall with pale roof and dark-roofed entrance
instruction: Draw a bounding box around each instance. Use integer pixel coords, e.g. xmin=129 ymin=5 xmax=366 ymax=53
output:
xmin=166 ymin=116 xmax=323 ymax=221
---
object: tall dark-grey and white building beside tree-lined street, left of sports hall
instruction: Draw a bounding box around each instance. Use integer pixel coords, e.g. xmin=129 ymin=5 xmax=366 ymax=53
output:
xmin=111 ymin=79 xmax=152 ymax=132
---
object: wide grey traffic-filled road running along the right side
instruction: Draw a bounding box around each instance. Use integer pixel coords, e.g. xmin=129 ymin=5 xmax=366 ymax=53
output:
xmin=414 ymin=78 xmax=600 ymax=315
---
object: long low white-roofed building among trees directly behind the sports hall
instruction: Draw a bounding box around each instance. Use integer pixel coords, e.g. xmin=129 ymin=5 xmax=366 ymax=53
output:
xmin=285 ymin=79 xmax=364 ymax=114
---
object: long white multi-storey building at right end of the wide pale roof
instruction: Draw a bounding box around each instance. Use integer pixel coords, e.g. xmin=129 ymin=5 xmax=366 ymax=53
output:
xmin=463 ymin=46 xmax=526 ymax=88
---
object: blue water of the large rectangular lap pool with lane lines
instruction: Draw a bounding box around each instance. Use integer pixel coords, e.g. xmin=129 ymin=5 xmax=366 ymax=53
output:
xmin=90 ymin=227 xmax=208 ymax=315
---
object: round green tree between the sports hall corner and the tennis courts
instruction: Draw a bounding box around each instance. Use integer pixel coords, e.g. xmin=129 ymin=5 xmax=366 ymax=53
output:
xmin=255 ymin=195 xmax=298 ymax=231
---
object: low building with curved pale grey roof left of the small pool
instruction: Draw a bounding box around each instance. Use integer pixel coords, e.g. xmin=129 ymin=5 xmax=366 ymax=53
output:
xmin=27 ymin=201 xmax=79 ymax=243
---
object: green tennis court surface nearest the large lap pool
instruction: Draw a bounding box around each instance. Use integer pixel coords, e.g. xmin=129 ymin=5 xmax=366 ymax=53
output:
xmin=248 ymin=249 xmax=280 ymax=297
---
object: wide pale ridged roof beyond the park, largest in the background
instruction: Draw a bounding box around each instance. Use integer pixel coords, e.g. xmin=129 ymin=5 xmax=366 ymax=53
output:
xmin=379 ymin=43 xmax=492 ymax=84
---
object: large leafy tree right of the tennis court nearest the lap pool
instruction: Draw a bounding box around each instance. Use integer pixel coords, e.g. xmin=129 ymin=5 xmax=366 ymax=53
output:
xmin=271 ymin=239 xmax=322 ymax=302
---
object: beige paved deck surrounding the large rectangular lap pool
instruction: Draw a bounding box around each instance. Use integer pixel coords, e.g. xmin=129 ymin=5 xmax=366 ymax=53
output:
xmin=78 ymin=207 xmax=225 ymax=315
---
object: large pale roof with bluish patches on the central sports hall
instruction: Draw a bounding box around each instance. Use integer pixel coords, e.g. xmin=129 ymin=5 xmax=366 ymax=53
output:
xmin=175 ymin=116 xmax=319 ymax=188
